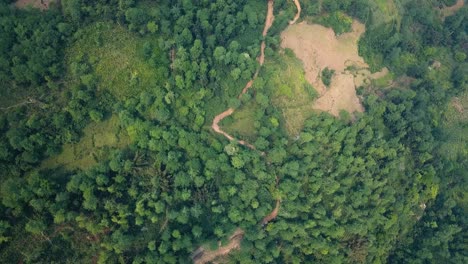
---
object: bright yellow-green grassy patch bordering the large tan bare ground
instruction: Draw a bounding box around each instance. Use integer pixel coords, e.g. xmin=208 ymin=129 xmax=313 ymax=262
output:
xmin=264 ymin=49 xmax=317 ymax=136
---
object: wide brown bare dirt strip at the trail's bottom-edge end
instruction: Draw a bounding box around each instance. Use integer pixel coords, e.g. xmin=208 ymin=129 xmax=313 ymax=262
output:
xmin=192 ymin=228 xmax=244 ymax=264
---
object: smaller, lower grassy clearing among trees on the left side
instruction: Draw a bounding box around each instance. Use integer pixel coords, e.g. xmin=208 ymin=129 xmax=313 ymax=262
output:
xmin=41 ymin=115 xmax=130 ymax=169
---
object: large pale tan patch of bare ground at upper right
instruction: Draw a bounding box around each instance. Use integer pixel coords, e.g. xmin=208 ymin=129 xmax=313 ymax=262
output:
xmin=281 ymin=21 xmax=388 ymax=116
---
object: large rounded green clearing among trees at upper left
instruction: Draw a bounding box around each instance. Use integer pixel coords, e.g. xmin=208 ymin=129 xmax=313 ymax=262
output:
xmin=67 ymin=22 xmax=169 ymax=99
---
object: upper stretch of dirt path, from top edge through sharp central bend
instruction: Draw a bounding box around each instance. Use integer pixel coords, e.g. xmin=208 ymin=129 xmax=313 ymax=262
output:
xmin=211 ymin=0 xmax=275 ymax=149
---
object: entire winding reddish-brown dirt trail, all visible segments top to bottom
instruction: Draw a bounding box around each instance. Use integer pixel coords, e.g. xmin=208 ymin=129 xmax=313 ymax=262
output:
xmin=191 ymin=0 xmax=301 ymax=264
